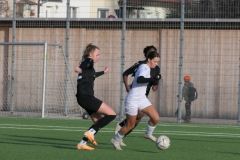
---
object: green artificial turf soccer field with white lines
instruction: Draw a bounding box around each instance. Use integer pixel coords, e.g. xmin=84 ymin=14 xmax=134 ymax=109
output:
xmin=0 ymin=117 xmax=240 ymax=160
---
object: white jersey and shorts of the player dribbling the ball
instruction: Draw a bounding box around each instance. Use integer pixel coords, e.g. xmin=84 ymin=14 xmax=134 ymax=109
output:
xmin=125 ymin=64 xmax=151 ymax=115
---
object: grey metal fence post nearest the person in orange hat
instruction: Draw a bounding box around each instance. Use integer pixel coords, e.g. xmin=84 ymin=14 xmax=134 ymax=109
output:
xmin=177 ymin=0 xmax=185 ymax=123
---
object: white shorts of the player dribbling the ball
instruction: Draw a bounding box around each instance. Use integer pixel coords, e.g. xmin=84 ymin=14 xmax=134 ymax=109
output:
xmin=125 ymin=97 xmax=152 ymax=116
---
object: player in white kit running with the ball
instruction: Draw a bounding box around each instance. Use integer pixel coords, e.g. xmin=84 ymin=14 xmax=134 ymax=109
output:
xmin=111 ymin=51 xmax=161 ymax=150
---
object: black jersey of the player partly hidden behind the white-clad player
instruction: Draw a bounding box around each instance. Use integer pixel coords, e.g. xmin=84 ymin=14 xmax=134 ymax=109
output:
xmin=123 ymin=61 xmax=160 ymax=96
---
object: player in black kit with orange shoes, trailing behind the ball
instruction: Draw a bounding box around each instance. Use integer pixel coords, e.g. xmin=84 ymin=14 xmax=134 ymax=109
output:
xmin=76 ymin=44 xmax=116 ymax=150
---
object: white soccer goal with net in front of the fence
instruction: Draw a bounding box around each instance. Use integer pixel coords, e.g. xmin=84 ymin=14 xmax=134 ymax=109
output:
xmin=0 ymin=42 xmax=83 ymax=118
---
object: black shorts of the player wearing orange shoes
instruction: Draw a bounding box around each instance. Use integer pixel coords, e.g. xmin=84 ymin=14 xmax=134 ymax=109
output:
xmin=77 ymin=94 xmax=103 ymax=115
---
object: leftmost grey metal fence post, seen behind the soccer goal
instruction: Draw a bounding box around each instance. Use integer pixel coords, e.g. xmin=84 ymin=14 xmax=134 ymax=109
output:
xmin=10 ymin=0 xmax=16 ymax=115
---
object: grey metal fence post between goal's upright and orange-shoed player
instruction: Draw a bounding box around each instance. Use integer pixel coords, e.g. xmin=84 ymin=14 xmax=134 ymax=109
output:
xmin=64 ymin=0 xmax=70 ymax=116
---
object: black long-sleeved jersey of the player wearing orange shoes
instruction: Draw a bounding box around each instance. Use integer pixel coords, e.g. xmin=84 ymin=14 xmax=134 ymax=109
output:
xmin=77 ymin=58 xmax=104 ymax=95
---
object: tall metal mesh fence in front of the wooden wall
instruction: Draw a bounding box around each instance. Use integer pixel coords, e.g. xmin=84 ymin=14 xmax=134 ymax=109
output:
xmin=0 ymin=0 xmax=240 ymax=122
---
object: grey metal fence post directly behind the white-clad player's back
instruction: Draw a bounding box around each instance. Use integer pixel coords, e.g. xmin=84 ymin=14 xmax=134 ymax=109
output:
xmin=119 ymin=0 xmax=126 ymax=120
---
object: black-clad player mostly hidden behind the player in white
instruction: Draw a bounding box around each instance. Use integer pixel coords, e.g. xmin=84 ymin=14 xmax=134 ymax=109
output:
xmin=114 ymin=45 xmax=160 ymax=146
